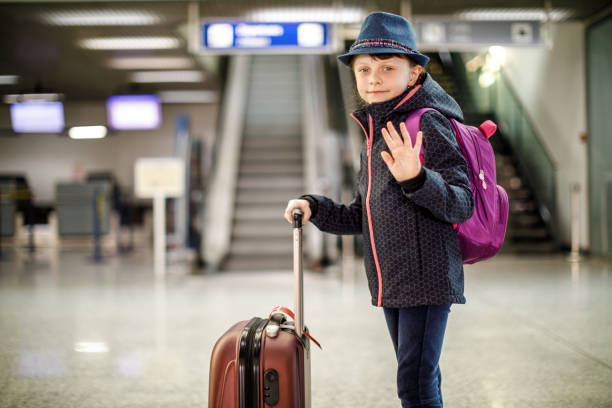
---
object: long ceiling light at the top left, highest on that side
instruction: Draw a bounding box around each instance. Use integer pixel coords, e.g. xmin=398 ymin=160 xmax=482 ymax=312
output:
xmin=41 ymin=10 xmax=162 ymax=26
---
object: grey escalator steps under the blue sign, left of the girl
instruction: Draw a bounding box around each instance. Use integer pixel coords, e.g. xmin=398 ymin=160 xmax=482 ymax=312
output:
xmin=222 ymin=55 xmax=303 ymax=270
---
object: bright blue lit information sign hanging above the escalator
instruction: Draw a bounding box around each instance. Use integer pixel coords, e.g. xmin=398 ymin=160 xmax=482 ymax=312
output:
xmin=202 ymin=21 xmax=329 ymax=53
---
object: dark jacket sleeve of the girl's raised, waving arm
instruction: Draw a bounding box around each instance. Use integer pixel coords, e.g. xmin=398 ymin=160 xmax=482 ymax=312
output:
xmin=402 ymin=112 xmax=474 ymax=223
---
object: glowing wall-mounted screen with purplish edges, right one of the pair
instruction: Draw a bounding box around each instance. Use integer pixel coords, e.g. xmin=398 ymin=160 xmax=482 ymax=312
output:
xmin=106 ymin=95 xmax=162 ymax=130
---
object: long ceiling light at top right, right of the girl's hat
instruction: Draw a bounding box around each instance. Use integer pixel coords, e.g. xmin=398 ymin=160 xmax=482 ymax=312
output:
xmin=456 ymin=8 xmax=572 ymax=21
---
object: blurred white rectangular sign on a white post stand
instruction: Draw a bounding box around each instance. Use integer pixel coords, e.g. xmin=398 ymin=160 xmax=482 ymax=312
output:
xmin=134 ymin=157 xmax=185 ymax=276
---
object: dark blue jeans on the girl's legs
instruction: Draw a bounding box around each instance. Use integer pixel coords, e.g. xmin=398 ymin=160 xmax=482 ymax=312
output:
xmin=383 ymin=304 xmax=451 ymax=408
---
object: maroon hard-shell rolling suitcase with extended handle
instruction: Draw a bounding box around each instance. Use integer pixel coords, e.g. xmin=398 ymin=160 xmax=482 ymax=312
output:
xmin=208 ymin=210 xmax=314 ymax=408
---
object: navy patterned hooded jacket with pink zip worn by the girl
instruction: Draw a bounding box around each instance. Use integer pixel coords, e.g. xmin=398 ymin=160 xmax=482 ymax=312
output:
xmin=307 ymin=74 xmax=474 ymax=307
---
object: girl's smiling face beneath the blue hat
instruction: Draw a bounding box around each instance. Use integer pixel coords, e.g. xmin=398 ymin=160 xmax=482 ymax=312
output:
xmin=353 ymin=54 xmax=422 ymax=103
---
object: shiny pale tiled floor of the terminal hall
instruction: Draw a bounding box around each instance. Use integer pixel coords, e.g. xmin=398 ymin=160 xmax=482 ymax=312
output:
xmin=0 ymin=252 xmax=612 ymax=408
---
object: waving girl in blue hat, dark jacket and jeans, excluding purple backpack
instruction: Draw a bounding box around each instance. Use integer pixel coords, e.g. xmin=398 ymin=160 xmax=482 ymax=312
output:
xmin=285 ymin=13 xmax=474 ymax=408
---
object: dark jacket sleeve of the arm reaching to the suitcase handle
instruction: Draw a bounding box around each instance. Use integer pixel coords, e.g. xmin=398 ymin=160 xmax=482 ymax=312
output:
xmin=308 ymin=192 xmax=361 ymax=235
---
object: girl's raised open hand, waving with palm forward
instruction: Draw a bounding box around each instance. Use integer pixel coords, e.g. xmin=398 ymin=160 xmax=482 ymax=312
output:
xmin=381 ymin=122 xmax=423 ymax=183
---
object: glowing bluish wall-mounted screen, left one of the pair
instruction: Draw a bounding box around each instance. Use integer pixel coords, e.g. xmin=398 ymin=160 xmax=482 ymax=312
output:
xmin=11 ymin=101 xmax=64 ymax=133
